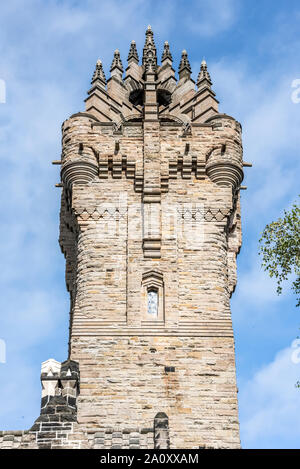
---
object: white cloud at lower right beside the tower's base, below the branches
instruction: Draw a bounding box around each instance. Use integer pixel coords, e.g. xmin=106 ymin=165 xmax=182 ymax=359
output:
xmin=239 ymin=347 xmax=300 ymax=448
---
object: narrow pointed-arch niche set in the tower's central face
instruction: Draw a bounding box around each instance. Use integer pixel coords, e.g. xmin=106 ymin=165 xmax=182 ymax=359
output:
xmin=142 ymin=270 xmax=165 ymax=323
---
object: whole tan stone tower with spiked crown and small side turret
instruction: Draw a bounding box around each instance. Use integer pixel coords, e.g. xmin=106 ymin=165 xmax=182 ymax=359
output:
xmin=0 ymin=26 xmax=247 ymax=448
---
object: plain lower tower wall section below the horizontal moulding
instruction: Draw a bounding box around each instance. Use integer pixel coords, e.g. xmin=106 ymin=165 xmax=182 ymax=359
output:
xmin=72 ymin=336 xmax=240 ymax=449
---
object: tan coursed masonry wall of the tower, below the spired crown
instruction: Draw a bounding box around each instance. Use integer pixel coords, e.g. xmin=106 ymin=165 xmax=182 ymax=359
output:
xmin=57 ymin=111 xmax=242 ymax=448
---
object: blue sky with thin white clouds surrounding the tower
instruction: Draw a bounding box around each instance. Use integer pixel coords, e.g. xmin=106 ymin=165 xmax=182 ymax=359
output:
xmin=0 ymin=0 xmax=300 ymax=448
